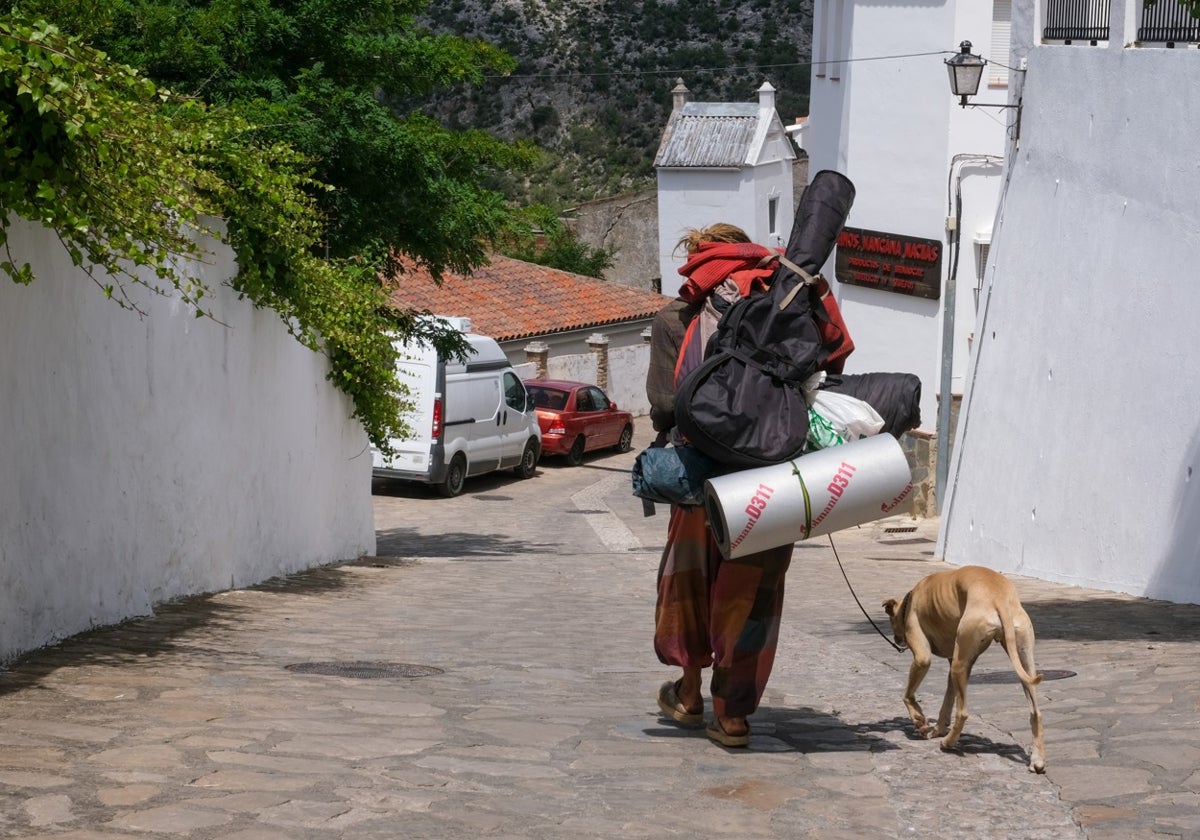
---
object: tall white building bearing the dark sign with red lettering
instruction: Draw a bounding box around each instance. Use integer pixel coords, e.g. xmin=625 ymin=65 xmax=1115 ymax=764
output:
xmin=806 ymin=0 xmax=1015 ymax=453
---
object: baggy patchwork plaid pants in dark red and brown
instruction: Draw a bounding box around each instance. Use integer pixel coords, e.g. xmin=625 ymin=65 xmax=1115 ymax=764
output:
xmin=654 ymin=505 xmax=792 ymax=718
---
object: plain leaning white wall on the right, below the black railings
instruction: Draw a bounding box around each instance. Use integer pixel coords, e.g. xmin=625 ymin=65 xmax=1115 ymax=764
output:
xmin=938 ymin=16 xmax=1200 ymax=602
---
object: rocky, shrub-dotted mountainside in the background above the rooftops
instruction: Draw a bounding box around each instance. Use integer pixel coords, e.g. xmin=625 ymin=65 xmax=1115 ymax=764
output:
xmin=412 ymin=0 xmax=812 ymax=206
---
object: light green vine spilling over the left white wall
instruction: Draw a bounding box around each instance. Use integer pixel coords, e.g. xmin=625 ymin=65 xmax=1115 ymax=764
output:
xmin=0 ymin=9 xmax=446 ymax=449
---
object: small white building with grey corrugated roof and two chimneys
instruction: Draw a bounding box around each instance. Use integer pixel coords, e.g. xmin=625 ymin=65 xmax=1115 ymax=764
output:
xmin=654 ymin=79 xmax=796 ymax=296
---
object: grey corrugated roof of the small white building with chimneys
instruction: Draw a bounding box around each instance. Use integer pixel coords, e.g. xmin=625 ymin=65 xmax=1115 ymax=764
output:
xmin=654 ymin=102 xmax=758 ymax=167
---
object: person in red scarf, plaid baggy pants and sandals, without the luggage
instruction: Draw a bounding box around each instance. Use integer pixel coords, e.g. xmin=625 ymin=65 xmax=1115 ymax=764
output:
xmin=646 ymin=223 xmax=792 ymax=746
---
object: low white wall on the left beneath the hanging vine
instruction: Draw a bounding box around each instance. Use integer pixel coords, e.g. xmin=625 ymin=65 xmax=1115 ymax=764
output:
xmin=0 ymin=221 xmax=374 ymax=661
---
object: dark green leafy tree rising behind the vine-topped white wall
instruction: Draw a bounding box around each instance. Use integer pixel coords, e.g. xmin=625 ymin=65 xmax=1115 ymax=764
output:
xmin=23 ymin=0 xmax=533 ymax=276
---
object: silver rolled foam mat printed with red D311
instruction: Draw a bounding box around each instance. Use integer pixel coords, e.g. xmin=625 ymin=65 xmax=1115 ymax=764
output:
xmin=704 ymin=434 xmax=912 ymax=558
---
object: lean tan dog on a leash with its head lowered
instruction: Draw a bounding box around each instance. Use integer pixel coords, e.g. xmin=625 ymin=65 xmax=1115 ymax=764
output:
xmin=883 ymin=566 xmax=1045 ymax=773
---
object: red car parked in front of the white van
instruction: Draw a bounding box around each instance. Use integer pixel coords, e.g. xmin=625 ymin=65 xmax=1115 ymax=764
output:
xmin=524 ymin=379 xmax=634 ymax=466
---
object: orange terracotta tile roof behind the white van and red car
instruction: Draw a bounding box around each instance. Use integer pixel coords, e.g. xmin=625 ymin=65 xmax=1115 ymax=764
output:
xmin=391 ymin=254 xmax=671 ymax=341
